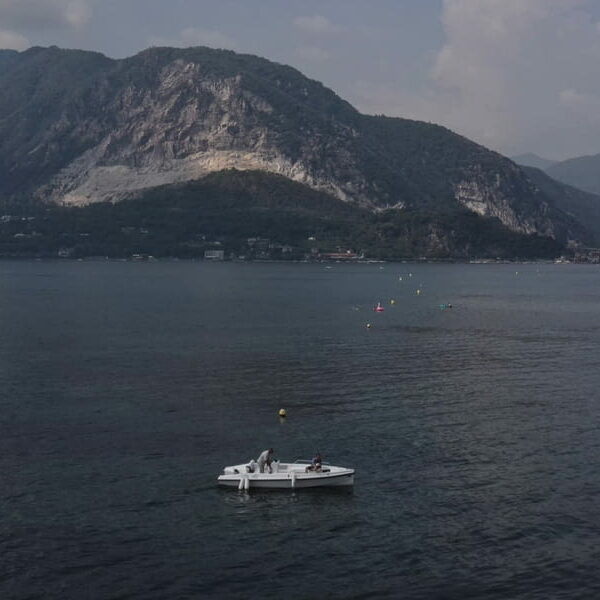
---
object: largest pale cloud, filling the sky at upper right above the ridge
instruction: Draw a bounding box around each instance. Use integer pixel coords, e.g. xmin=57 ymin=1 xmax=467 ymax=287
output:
xmin=357 ymin=0 xmax=600 ymax=158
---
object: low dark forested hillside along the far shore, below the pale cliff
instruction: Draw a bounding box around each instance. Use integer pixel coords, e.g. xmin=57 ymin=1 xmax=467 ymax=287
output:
xmin=0 ymin=170 xmax=564 ymax=260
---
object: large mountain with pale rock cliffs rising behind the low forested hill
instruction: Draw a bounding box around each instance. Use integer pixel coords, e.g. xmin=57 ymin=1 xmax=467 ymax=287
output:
xmin=0 ymin=47 xmax=586 ymax=251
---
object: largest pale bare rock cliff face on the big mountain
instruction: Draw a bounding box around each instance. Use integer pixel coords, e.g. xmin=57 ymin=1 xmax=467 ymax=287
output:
xmin=38 ymin=60 xmax=366 ymax=204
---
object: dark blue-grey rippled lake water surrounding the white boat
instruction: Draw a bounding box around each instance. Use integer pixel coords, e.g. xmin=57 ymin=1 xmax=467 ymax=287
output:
xmin=0 ymin=262 xmax=600 ymax=600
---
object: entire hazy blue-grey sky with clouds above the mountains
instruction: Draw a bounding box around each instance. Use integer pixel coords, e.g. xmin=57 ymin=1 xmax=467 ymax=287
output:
xmin=0 ymin=0 xmax=600 ymax=159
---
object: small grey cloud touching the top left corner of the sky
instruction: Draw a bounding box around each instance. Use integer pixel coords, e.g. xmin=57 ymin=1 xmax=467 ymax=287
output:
xmin=0 ymin=0 xmax=92 ymax=31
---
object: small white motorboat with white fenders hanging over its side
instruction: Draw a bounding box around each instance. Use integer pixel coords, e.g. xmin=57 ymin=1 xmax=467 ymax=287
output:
xmin=218 ymin=460 xmax=354 ymax=490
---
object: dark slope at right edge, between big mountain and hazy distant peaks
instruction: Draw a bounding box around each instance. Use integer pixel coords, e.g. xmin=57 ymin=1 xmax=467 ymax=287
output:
xmin=524 ymin=167 xmax=600 ymax=246
